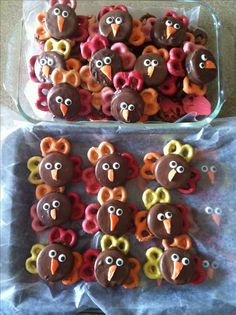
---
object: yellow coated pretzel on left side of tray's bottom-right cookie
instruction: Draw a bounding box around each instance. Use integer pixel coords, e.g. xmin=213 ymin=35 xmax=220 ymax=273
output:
xmin=143 ymin=247 xmax=162 ymax=279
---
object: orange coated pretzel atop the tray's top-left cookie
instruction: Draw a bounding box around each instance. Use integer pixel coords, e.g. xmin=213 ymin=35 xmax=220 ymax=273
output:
xmin=40 ymin=137 xmax=71 ymax=156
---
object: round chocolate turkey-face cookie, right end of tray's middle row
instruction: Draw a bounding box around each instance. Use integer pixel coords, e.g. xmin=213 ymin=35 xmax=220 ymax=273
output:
xmin=147 ymin=203 xmax=183 ymax=239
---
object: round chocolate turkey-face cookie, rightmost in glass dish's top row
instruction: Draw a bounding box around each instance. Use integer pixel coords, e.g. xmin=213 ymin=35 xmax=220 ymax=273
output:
xmin=151 ymin=16 xmax=187 ymax=48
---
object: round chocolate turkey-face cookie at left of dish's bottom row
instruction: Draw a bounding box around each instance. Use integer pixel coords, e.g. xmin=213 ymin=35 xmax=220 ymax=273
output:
xmin=47 ymin=83 xmax=80 ymax=119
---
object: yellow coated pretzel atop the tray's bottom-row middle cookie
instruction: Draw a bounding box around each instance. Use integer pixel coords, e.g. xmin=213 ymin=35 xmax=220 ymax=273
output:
xmin=101 ymin=234 xmax=130 ymax=255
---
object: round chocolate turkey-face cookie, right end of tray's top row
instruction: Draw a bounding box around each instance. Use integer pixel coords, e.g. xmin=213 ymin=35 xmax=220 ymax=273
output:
xmin=154 ymin=154 xmax=191 ymax=189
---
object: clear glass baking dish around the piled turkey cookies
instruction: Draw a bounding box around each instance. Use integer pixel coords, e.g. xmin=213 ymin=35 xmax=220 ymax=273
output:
xmin=7 ymin=0 xmax=224 ymax=129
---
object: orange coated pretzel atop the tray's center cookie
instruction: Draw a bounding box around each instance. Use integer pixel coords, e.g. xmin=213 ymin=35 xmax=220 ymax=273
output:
xmin=97 ymin=186 xmax=128 ymax=205
